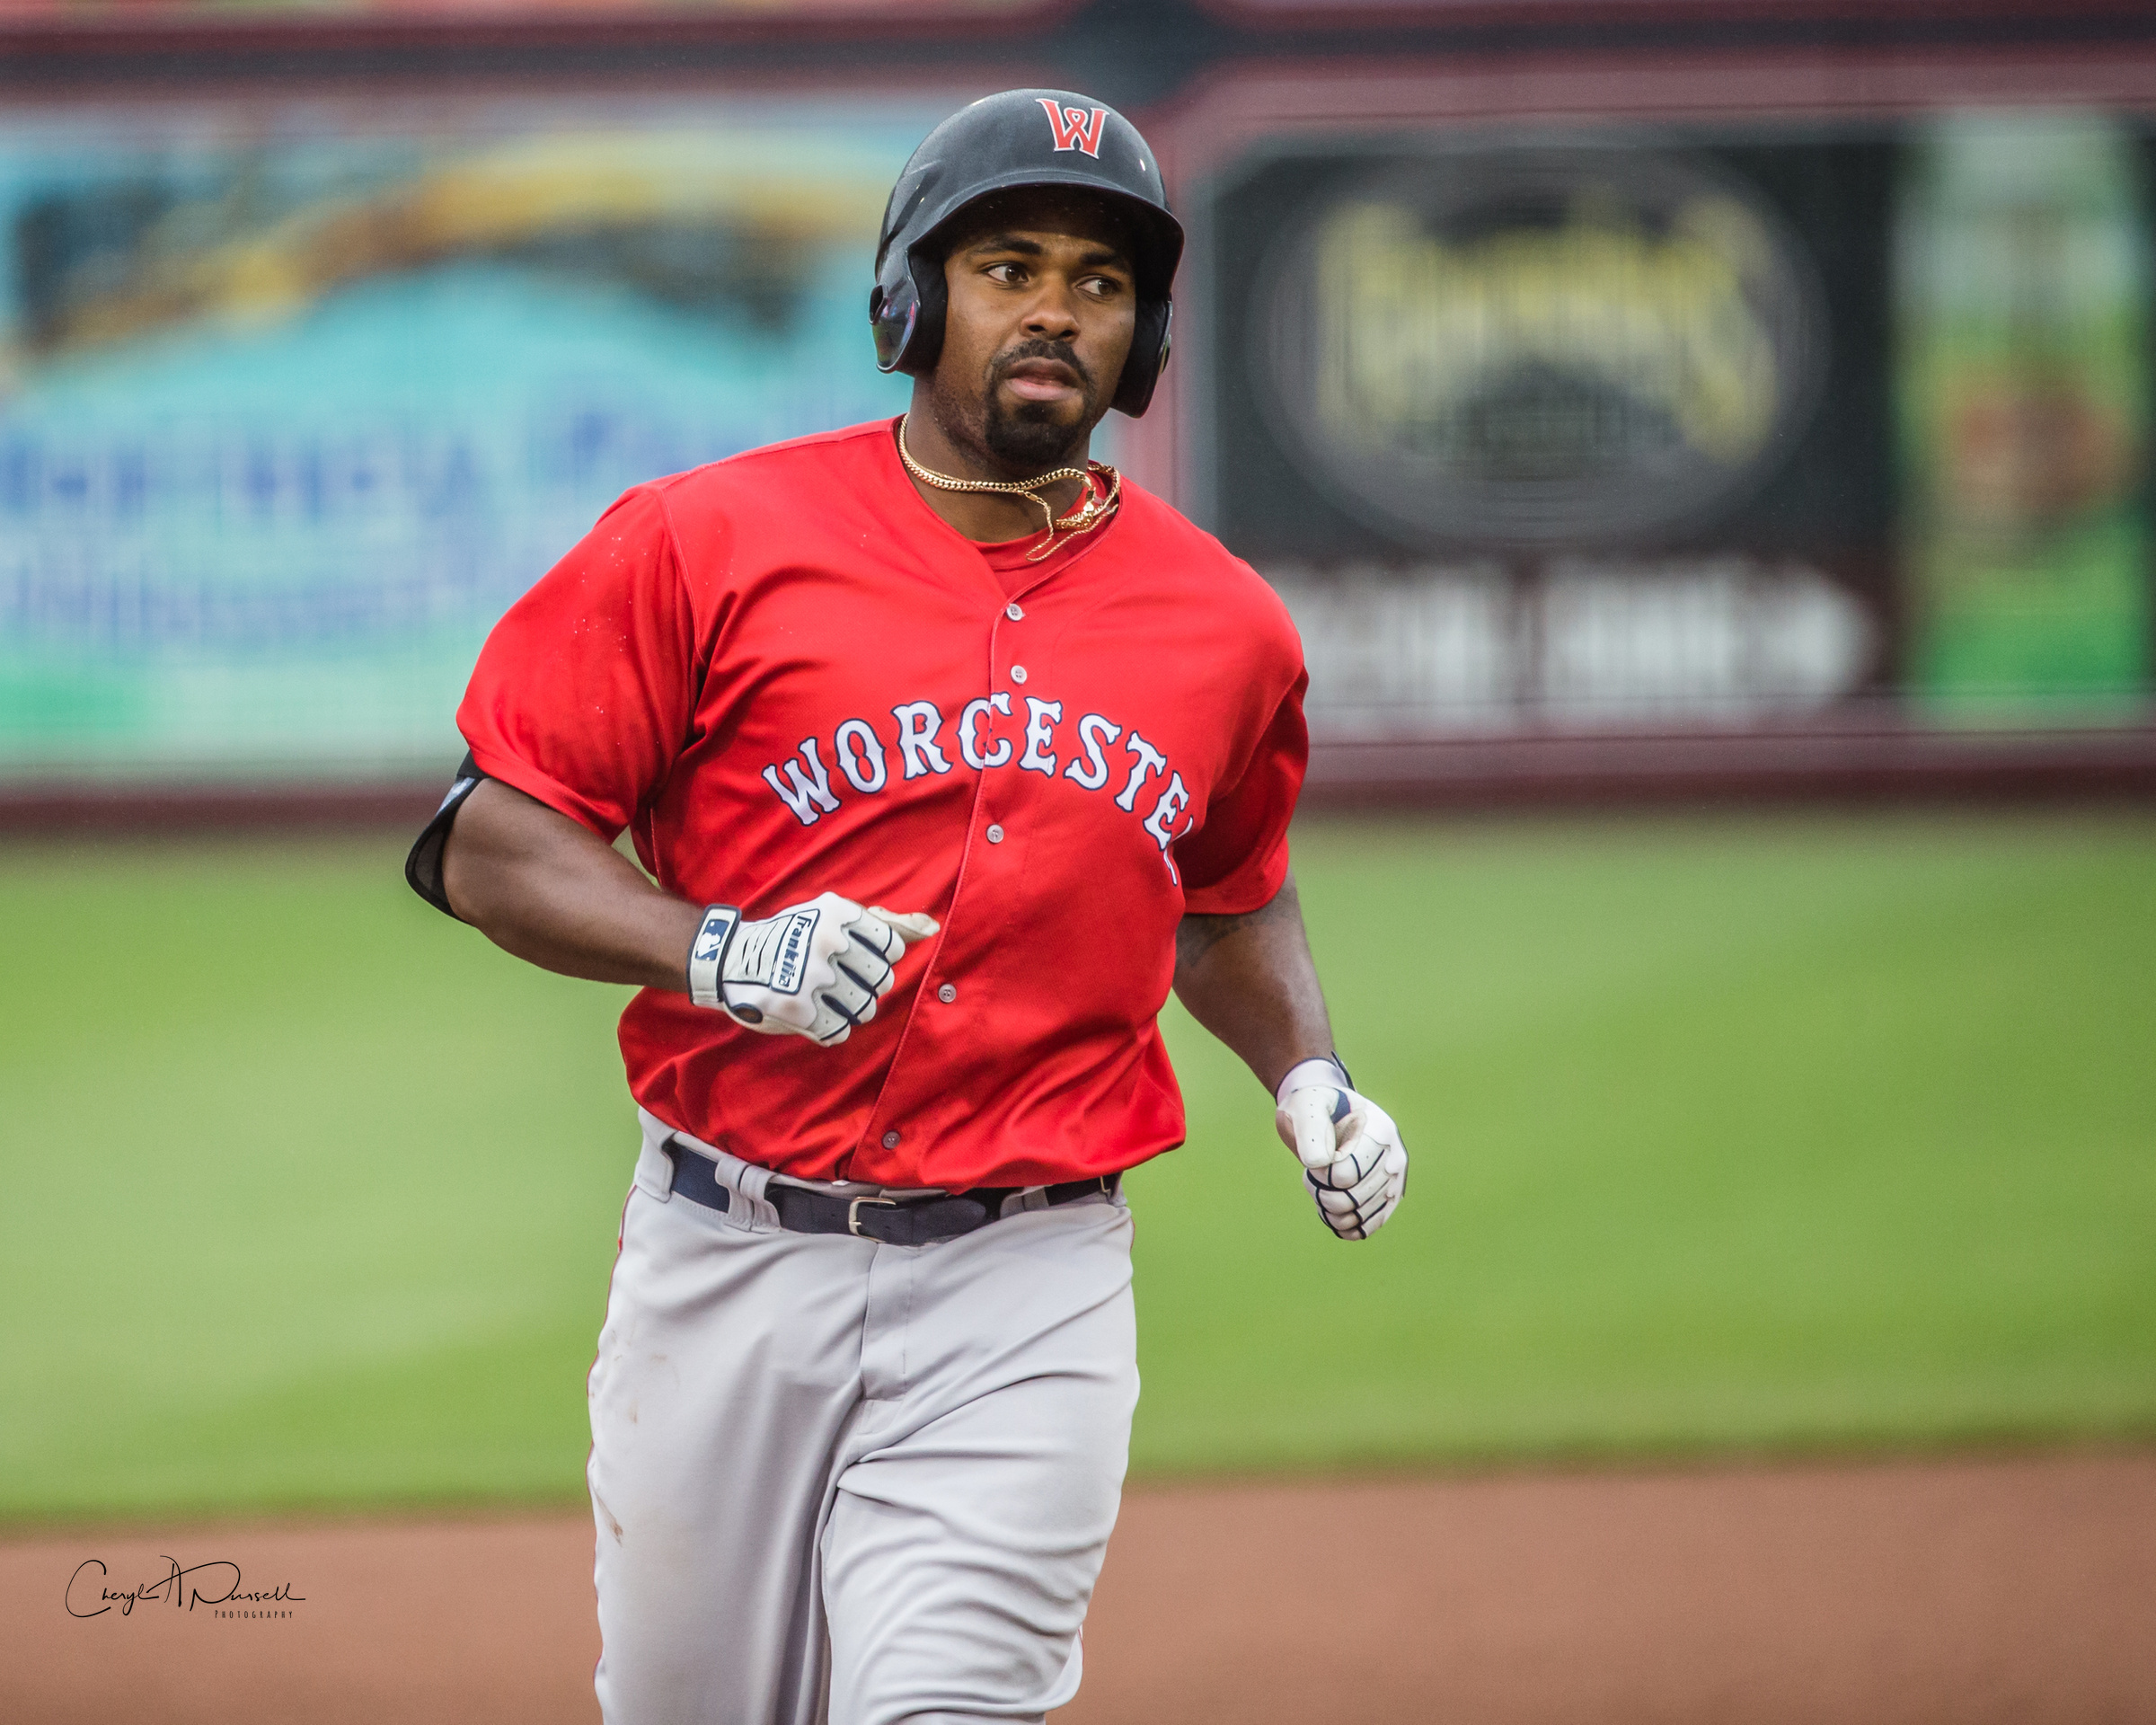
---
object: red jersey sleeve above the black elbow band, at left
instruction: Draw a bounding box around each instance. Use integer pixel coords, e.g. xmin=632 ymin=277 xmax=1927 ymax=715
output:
xmin=457 ymin=487 xmax=696 ymax=841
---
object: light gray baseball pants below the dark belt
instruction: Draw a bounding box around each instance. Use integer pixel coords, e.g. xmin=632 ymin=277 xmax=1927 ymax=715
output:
xmin=587 ymin=1115 xmax=1138 ymax=1725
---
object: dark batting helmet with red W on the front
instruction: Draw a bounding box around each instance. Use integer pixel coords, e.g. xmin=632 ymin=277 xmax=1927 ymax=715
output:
xmin=869 ymin=91 xmax=1184 ymax=419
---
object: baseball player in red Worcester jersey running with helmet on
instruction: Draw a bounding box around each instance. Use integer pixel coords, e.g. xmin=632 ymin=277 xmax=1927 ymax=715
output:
xmin=410 ymin=91 xmax=1408 ymax=1725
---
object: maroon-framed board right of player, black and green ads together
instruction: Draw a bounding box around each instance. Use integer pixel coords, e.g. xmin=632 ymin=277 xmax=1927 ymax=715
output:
xmin=1186 ymin=101 xmax=2152 ymax=738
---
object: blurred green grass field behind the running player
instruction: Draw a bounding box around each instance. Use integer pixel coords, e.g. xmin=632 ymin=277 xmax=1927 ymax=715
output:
xmin=0 ymin=818 xmax=2156 ymax=1522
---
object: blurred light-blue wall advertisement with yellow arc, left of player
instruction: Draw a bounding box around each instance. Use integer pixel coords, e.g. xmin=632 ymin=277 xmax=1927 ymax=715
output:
xmin=0 ymin=95 xmax=958 ymax=781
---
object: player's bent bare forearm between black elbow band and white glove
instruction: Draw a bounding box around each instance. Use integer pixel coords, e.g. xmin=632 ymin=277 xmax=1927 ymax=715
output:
xmin=442 ymin=778 xmax=702 ymax=992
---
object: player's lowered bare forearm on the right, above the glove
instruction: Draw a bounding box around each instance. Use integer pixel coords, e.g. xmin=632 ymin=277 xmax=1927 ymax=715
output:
xmin=1175 ymin=875 xmax=1332 ymax=1091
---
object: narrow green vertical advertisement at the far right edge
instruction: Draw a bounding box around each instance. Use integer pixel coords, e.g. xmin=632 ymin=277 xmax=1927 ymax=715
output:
xmin=1895 ymin=112 xmax=2156 ymax=716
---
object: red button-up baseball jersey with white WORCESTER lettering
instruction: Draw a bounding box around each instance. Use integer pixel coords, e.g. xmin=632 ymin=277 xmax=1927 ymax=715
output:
xmin=457 ymin=420 xmax=1309 ymax=1190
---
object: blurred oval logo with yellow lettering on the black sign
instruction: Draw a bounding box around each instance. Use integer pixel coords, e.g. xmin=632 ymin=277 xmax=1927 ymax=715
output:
xmin=1255 ymin=146 xmax=1822 ymax=545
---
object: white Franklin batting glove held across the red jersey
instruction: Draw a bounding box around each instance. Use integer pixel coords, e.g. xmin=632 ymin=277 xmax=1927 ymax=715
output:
xmin=688 ymin=893 xmax=936 ymax=1048
